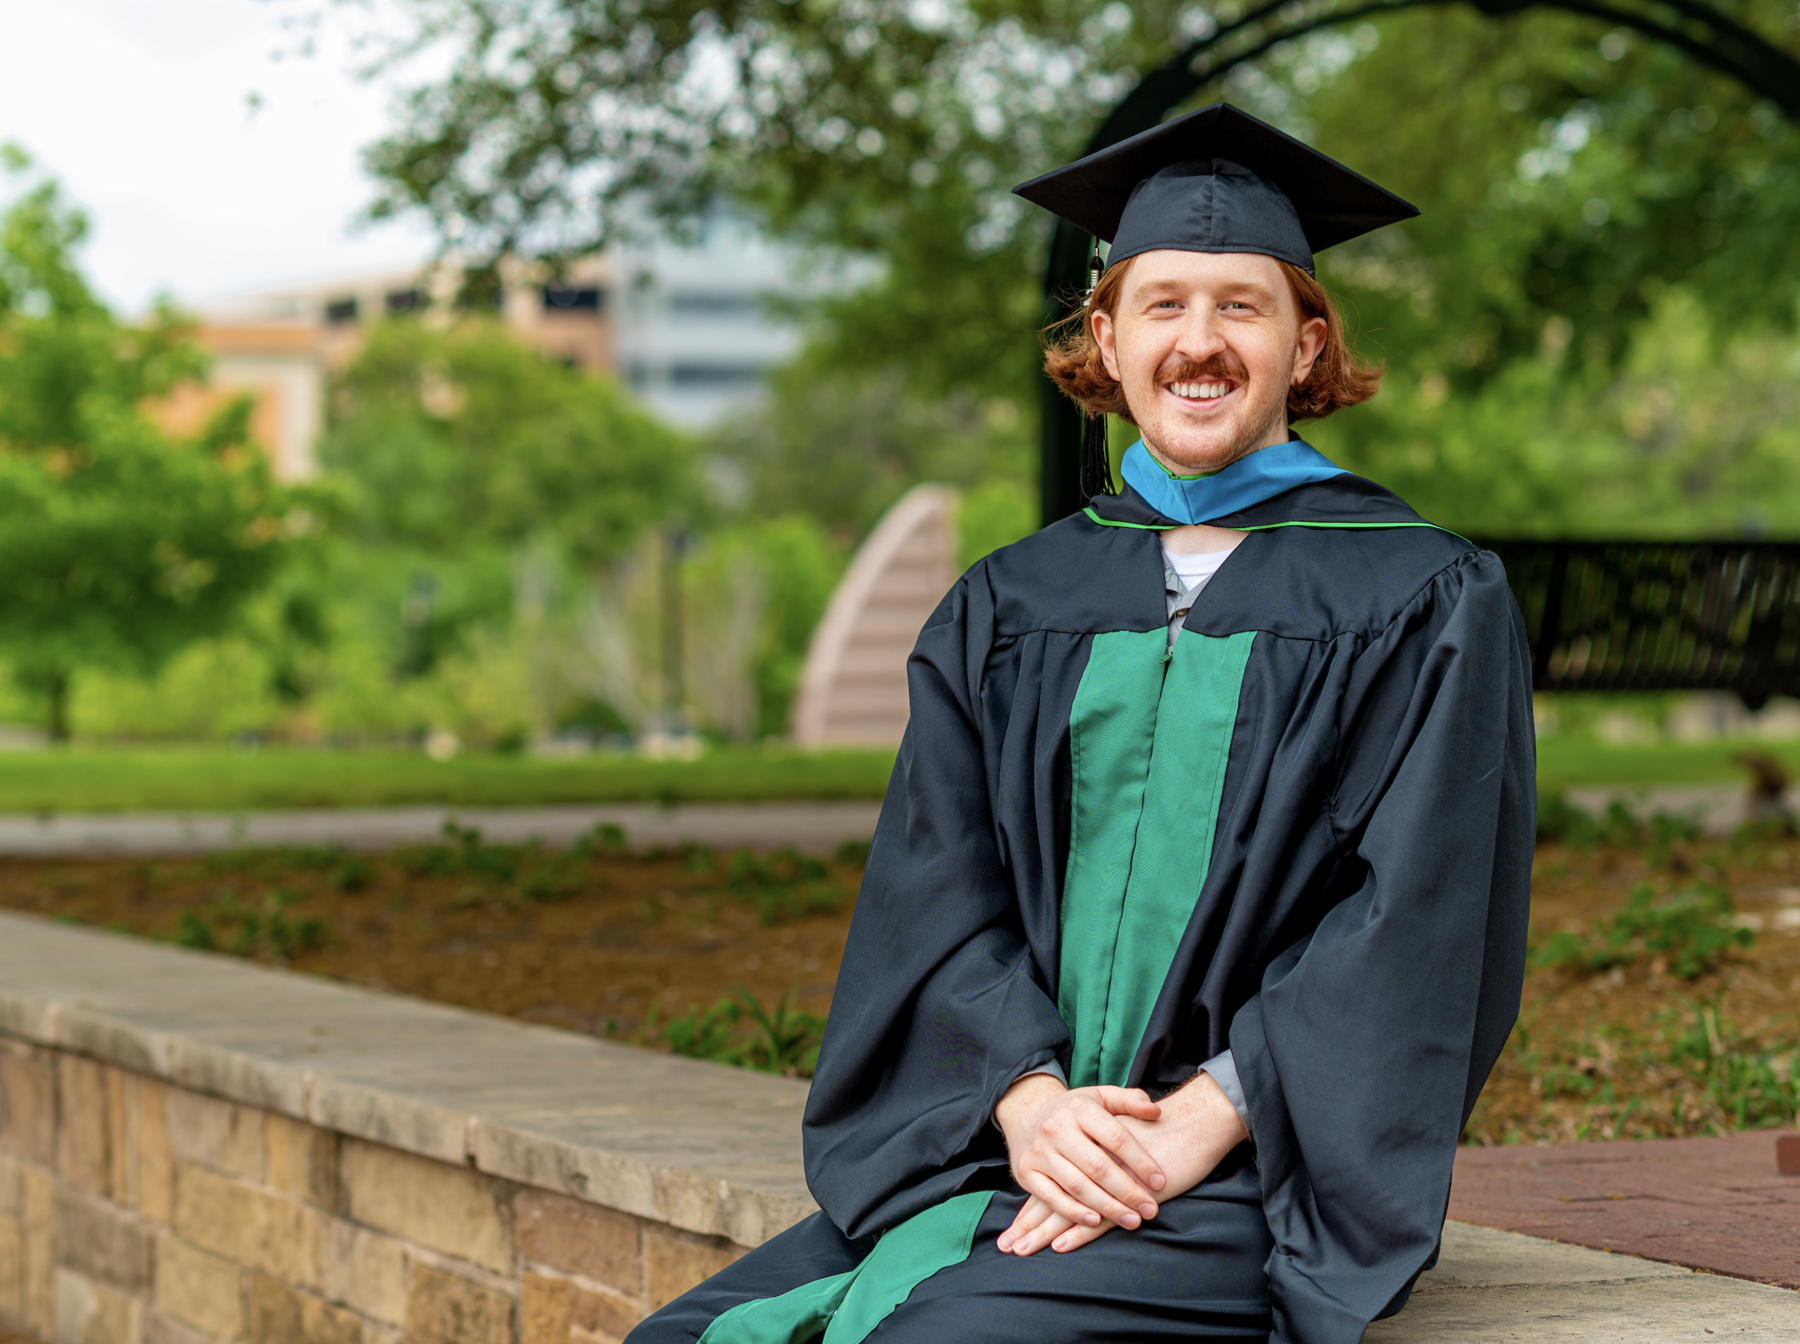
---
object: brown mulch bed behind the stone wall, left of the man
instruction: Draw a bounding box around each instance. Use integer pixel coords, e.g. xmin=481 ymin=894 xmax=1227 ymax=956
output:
xmin=0 ymin=846 xmax=860 ymax=1044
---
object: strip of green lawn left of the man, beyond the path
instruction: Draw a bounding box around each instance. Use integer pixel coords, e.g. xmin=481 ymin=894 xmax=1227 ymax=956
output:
xmin=0 ymin=747 xmax=893 ymax=813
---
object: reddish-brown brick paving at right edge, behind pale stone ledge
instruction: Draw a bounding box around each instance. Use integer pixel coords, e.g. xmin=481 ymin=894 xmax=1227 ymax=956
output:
xmin=1449 ymin=1130 xmax=1800 ymax=1288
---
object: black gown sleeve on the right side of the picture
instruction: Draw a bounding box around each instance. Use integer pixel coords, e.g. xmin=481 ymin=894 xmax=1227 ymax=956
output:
xmin=1231 ymin=552 xmax=1537 ymax=1344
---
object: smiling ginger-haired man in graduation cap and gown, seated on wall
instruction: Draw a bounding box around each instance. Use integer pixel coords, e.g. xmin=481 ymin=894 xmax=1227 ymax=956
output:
xmin=632 ymin=104 xmax=1535 ymax=1344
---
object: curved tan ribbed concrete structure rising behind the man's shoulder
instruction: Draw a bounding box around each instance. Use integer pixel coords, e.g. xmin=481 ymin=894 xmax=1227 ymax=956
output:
xmin=794 ymin=486 xmax=956 ymax=747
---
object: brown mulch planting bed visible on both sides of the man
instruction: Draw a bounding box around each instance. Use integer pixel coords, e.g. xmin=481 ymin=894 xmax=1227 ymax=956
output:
xmin=10 ymin=835 xmax=1800 ymax=1142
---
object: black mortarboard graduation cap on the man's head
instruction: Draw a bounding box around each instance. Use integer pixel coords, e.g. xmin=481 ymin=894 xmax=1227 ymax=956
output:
xmin=1013 ymin=103 xmax=1418 ymax=272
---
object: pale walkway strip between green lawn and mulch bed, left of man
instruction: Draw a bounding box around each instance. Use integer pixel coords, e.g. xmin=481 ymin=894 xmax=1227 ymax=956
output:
xmin=0 ymin=801 xmax=880 ymax=858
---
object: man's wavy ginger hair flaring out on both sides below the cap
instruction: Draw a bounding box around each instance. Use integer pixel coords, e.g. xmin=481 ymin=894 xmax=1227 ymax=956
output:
xmin=1044 ymin=257 xmax=1382 ymax=425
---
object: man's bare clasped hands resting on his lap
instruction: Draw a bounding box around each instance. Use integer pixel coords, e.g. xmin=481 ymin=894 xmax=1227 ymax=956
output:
xmin=994 ymin=1072 xmax=1249 ymax=1256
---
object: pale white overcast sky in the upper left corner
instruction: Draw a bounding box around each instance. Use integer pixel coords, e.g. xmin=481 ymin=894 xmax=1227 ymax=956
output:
xmin=0 ymin=0 xmax=430 ymax=313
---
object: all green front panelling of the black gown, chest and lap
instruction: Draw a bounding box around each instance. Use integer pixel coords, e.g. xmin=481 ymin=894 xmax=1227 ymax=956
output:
xmin=698 ymin=630 xmax=1256 ymax=1344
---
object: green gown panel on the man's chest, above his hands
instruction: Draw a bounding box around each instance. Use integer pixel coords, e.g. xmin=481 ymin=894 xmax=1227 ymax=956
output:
xmin=1057 ymin=630 xmax=1256 ymax=1087
